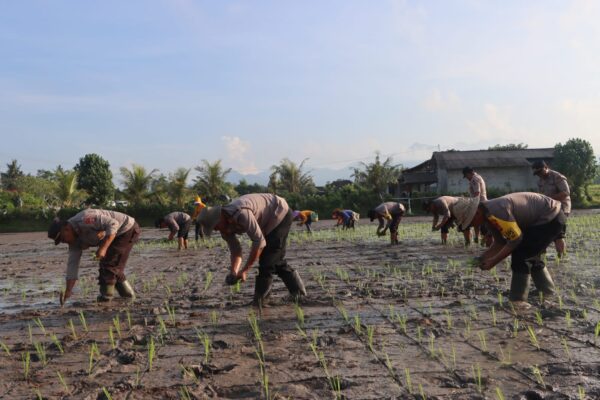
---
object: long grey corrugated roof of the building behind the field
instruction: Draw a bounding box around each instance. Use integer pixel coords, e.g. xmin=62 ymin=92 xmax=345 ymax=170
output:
xmin=432 ymin=148 xmax=554 ymax=169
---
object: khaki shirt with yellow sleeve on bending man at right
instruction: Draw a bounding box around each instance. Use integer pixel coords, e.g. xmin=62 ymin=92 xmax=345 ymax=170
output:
xmin=482 ymin=192 xmax=561 ymax=249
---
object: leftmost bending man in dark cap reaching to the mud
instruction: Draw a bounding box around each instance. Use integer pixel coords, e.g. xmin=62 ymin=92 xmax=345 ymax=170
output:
xmin=48 ymin=209 xmax=140 ymax=305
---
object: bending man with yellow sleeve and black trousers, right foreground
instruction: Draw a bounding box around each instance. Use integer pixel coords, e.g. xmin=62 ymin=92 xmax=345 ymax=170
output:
xmin=454 ymin=192 xmax=566 ymax=307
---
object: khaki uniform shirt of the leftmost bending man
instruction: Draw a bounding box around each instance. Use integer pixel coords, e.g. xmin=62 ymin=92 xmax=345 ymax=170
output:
xmin=67 ymin=209 xmax=135 ymax=279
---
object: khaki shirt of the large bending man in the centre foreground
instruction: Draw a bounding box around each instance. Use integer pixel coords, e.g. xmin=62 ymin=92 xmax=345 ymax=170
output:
xmin=221 ymin=193 xmax=290 ymax=255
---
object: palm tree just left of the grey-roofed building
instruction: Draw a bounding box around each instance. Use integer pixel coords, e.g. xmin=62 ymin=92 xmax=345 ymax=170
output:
xmin=352 ymin=152 xmax=401 ymax=194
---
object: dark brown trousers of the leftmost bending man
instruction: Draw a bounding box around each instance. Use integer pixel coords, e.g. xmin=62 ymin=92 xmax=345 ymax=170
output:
xmin=98 ymin=222 xmax=141 ymax=285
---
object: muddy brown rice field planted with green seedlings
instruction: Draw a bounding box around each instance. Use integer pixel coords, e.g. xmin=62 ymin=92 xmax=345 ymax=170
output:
xmin=0 ymin=212 xmax=600 ymax=399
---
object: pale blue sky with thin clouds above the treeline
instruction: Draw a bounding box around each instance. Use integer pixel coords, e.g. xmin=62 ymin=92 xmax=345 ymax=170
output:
xmin=0 ymin=0 xmax=600 ymax=183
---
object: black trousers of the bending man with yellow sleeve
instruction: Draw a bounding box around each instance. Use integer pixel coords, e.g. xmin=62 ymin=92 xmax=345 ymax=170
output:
xmin=510 ymin=211 xmax=566 ymax=274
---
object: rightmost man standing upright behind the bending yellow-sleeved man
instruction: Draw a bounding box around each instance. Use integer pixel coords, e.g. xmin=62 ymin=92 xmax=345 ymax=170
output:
xmin=531 ymin=161 xmax=571 ymax=257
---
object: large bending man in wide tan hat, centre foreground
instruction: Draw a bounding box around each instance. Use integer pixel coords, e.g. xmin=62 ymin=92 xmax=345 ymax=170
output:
xmin=215 ymin=193 xmax=306 ymax=306
